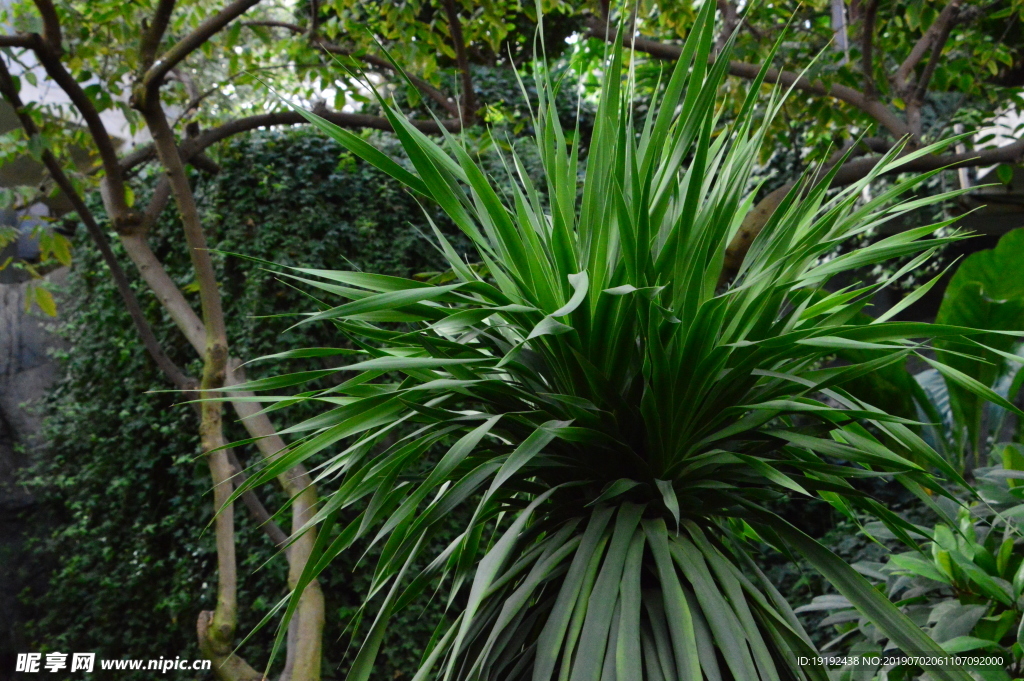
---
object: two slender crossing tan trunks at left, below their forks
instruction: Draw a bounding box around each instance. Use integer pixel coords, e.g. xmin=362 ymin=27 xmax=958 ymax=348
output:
xmin=128 ymin=102 xmax=324 ymax=681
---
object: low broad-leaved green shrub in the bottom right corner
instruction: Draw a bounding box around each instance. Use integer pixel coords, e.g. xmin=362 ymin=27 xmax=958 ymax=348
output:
xmin=796 ymin=471 xmax=1024 ymax=681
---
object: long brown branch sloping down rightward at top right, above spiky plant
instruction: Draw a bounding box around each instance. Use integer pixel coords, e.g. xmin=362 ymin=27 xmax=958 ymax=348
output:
xmin=587 ymin=17 xmax=909 ymax=137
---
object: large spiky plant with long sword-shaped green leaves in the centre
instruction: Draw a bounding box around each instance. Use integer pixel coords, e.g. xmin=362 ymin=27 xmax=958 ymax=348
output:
xmin=224 ymin=3 xmax=1015 ymax=681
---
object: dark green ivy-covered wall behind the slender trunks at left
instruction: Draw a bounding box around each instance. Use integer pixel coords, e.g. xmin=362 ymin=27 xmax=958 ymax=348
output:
xmin=18 ymin=125 xmax=475 ymax=679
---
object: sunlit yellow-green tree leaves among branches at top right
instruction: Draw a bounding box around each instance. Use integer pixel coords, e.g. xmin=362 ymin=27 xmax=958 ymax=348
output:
xmin=622 ymin=0 xmax=1022 ymax=157
